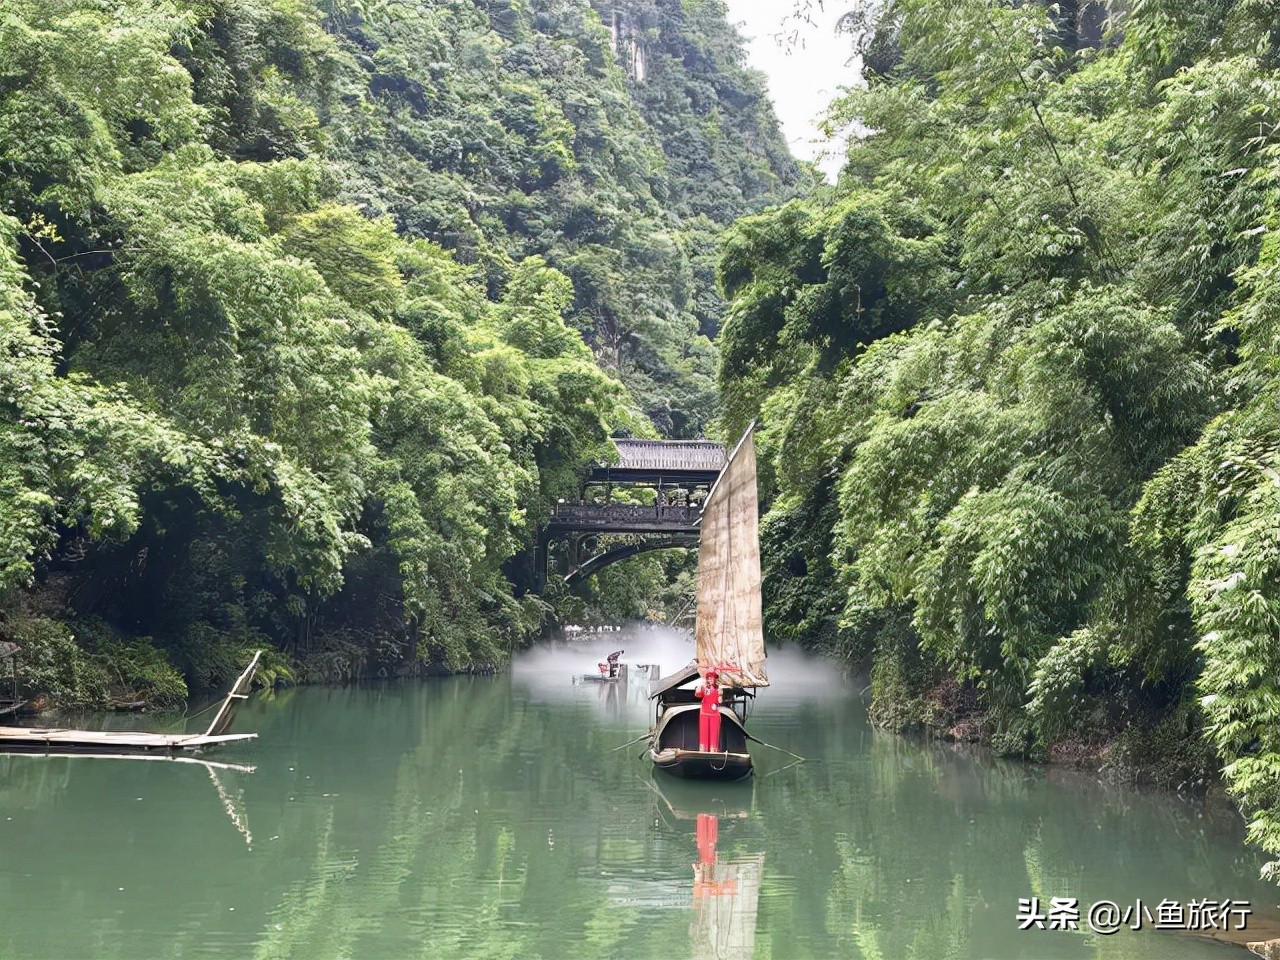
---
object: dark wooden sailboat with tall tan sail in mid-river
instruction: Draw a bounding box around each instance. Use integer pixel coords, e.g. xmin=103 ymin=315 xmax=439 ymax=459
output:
xmin=649 ymin=422 xmax=769 ymax=780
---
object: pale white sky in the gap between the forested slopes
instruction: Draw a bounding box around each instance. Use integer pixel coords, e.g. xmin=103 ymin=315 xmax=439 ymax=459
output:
xmin=726 ymin=0 xmax=861 ymax=180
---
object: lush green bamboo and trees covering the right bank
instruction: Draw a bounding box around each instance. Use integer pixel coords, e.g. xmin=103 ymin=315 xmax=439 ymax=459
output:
xmin=719 ymin=0 xmax=1280 ymax=851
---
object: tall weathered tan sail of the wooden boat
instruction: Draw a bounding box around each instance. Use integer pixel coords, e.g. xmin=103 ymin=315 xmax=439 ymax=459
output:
xmin=694 ymin=424 xmax=769 ymax=687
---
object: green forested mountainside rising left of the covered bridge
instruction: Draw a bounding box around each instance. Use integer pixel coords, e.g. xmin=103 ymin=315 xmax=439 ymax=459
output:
xmin=0 ymin=0 xmax=810 ymax=705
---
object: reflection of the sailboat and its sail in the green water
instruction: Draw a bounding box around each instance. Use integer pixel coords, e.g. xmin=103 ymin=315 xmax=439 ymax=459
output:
xmin=654 ymin=774 xmax=764 ymax=960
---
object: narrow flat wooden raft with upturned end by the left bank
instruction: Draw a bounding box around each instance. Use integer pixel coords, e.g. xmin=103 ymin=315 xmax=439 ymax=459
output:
xmin=0 ymin=650 xmax=262 ymax=756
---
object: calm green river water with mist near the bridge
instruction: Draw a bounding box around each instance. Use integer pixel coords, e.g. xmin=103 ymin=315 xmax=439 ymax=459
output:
xmin=0 ymin=632 xmax=1280 ymax=960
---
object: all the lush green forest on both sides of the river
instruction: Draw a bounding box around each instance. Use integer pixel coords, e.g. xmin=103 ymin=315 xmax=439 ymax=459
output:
xmin=12 ymin=0 xmax=1280 ymax=896
